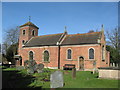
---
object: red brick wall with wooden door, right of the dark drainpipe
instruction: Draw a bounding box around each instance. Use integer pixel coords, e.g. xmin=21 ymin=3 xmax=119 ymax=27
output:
xmin=61 ymin=45 xmax=104 ymax=69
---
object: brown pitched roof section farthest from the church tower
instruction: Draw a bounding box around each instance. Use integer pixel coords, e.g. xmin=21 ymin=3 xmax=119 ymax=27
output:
xmin=62 ymin=32 xmax=101 ymax=45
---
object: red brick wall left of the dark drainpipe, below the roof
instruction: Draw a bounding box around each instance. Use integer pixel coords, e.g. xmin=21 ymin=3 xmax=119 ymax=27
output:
xmin=20 ymin=46 xmax=58 ymax=67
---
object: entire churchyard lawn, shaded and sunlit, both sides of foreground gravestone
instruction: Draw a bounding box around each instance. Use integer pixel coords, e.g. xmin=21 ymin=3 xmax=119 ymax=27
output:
xmin=2 ymin=68 xmax=118 ymax=88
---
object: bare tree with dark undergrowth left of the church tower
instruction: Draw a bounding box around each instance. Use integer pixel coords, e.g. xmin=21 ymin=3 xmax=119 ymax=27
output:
xmin=2 ymin=27 xmax=19 ymax=63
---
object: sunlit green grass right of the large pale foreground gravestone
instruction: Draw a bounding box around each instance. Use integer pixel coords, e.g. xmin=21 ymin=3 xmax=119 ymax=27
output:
xmin=64 ymin=71 xmax=118 ymax=88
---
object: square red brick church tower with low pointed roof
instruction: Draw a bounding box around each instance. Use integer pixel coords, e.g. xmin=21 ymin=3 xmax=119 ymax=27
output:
xmin=18 ymin=21 xmax=39 ymax=54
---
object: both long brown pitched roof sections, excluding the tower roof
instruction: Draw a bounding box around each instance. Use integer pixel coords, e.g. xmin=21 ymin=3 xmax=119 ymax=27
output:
xmin=25 ymin=32 xmax=101 ymax=47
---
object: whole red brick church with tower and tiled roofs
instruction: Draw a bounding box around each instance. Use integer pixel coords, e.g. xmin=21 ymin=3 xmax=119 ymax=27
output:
xmin=16 ymin=21 xmax=110 ymax=71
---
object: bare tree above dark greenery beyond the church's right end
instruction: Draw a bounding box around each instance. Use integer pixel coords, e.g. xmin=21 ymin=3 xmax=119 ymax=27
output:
xmin=106 ymin=28 xmax=120 ymax=63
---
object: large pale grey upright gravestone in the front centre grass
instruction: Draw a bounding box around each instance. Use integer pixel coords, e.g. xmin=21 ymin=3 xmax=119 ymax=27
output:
xmin=50 ymin=71 xmax=63 ymax=88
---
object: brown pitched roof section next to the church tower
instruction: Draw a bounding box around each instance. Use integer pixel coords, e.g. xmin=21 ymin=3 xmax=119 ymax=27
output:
xmin=25 ymin=33 xmax=63 ymax=47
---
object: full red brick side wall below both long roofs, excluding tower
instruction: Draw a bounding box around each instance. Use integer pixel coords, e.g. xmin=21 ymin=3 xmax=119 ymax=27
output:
xmin=20 ymin=45 xmax=109 ymax=69
